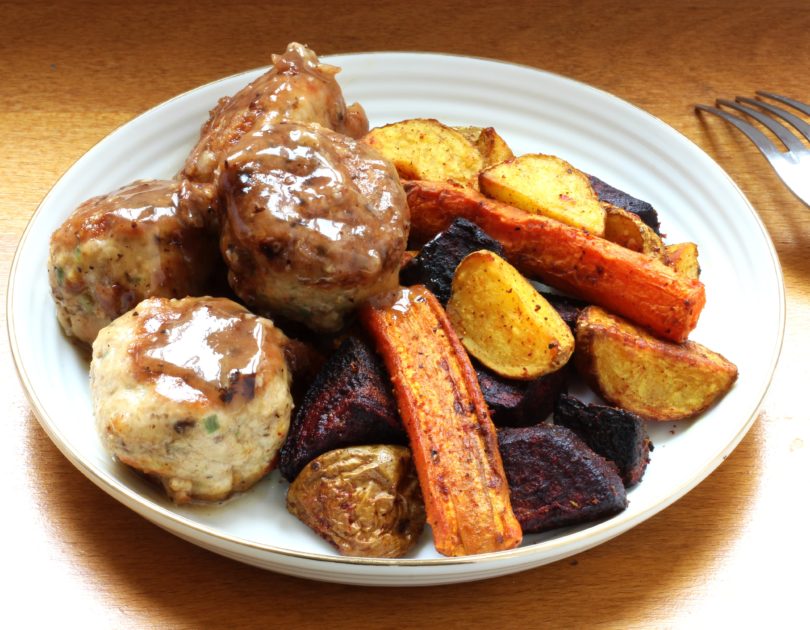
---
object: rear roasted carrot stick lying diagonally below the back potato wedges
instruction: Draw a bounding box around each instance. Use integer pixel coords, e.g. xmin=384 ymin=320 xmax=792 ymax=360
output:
xmin=405 ymin=181 xmax=706 ymax=342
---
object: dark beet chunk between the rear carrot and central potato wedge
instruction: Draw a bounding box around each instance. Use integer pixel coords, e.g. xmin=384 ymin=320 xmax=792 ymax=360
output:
xmin=399 ymin=219 xmax=503 ymax=304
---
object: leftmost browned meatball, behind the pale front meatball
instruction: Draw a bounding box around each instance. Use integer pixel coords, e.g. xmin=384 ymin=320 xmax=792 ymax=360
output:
xmin=48 ymin=180 xmax=218 ymax=344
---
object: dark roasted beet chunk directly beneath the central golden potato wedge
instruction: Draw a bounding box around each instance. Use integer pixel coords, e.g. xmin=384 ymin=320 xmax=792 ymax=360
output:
xmin=474 ymin=362 xmax=568 ymax=427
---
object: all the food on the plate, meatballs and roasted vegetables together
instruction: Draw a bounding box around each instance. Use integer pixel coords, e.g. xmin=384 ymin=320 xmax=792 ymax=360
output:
xmin=53 ymin=42 xmax=737 ymax=557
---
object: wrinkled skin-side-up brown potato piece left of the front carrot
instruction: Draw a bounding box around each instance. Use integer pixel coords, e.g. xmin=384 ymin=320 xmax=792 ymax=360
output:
xmin=287 ymin=445 xmax=425 ymax=558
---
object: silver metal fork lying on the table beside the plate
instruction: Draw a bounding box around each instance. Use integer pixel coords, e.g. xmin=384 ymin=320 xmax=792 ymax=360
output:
xmin=695 ymin=91 xmax=810 ymax=206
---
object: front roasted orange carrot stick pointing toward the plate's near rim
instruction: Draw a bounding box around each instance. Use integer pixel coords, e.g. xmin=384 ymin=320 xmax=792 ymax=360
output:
xmin=360 ymin=285 xmax=522 ymax=556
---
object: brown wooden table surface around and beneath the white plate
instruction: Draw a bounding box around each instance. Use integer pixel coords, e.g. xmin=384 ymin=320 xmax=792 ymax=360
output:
xmin=0 ymin=0 xmax=810 ymax=628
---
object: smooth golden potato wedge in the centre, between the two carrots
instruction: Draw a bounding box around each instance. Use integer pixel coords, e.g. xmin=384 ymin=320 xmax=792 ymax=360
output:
xmin=447 ymin=250 xmax=574 ymax=380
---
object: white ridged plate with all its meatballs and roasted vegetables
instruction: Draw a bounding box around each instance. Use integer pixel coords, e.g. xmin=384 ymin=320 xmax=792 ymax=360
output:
xmin=7 ymin=45 xmax=784 ymax=585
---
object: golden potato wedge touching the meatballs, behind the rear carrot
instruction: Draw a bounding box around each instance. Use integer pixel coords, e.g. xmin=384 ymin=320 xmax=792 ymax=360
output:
xmin=364 ymin=118 xmax=484 ymax=185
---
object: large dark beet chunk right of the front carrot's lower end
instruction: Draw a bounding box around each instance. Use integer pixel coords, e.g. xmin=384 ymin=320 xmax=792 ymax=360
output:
xmin=498 ymin=424 xmax=627 ymax=534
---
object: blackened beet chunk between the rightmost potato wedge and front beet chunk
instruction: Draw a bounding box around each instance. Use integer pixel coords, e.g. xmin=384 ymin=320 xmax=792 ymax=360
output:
xmin=554 ymin=394 xmax=653 ymax=488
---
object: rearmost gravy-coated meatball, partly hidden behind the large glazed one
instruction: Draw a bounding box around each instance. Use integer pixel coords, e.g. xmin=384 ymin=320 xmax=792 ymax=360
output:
xmin=182 ymin=42 xmax=368 ymax=216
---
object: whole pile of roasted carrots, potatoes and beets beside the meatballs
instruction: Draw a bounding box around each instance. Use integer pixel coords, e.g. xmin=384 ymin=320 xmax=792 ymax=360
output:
xmin=280 ymin=119 xmax=737 ymax=557
